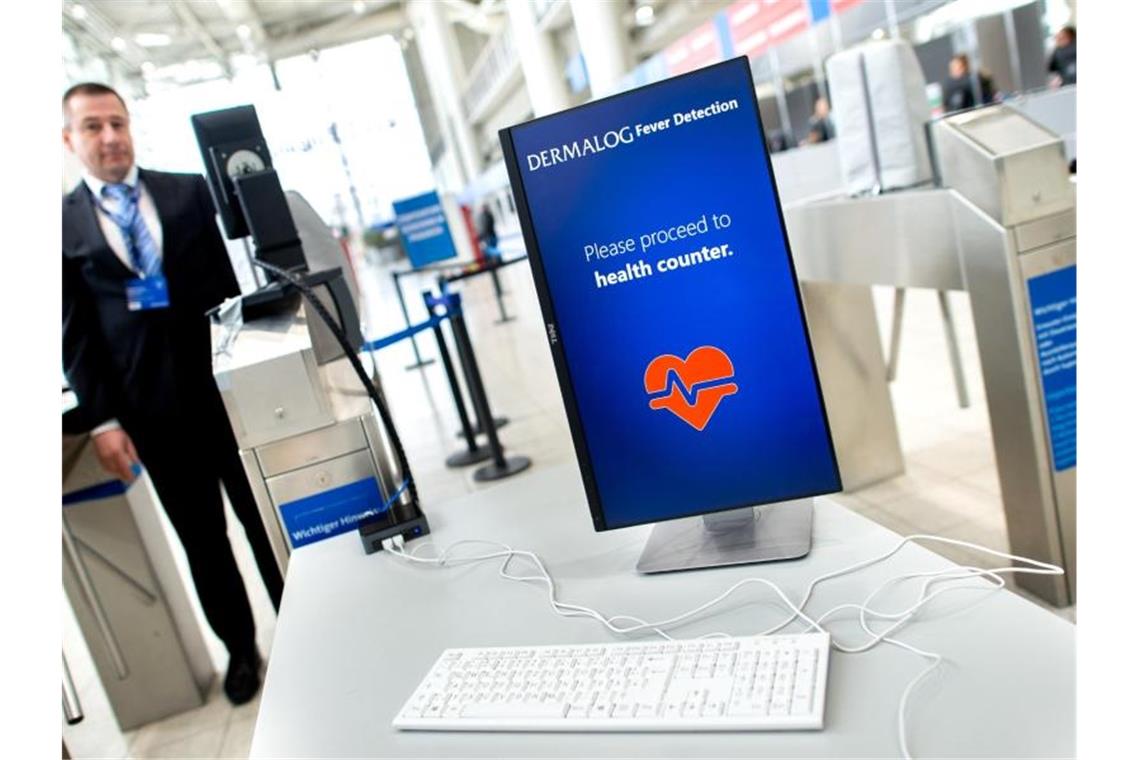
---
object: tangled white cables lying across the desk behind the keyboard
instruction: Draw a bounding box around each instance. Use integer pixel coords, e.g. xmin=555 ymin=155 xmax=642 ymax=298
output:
xmin=383 ymin=533 xmax=1064 ymax=760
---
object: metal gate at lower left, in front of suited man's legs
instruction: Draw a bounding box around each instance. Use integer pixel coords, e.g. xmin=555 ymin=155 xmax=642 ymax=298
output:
xmin=63 ymin=435 xmax=214 ymax=732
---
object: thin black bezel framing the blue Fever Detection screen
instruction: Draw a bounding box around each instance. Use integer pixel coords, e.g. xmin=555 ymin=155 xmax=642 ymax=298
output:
xmin=499 ymin=56 xmax=842 ymax=532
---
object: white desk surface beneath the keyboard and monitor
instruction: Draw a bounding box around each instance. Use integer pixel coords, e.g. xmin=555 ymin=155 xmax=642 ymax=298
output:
xmin=251 ymin=466 xmax=1076 ymax=758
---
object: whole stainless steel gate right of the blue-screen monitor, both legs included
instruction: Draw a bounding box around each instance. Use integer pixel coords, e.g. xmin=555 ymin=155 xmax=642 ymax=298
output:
xmin=776 ymin=106 xmax=1076 ymax=606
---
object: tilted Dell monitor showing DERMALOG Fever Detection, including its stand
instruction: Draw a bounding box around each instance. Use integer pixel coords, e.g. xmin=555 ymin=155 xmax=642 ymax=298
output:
xmin=499 ymin=57 xmax=841 ymax=572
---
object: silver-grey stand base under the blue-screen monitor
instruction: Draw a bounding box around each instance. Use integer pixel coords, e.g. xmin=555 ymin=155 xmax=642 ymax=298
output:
xmin=637 ymin=499 xmax=813 ymax=573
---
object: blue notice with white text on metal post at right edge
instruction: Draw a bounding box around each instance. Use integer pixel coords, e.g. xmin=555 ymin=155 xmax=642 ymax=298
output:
xmin=1027 ymin=265 xmax=1076 ymax=472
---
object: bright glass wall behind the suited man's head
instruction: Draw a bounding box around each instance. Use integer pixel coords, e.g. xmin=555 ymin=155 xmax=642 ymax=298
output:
xmin=133 ymin=36 xmax=433 ymax=229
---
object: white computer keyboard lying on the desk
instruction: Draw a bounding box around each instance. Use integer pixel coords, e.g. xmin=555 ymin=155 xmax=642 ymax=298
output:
xmin=392 ymin=634 xmax=830 ymax=732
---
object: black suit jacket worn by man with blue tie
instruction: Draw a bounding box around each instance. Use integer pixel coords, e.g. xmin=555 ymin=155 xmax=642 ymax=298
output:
xmin=63 ymin=170 xmax=239 ymax=438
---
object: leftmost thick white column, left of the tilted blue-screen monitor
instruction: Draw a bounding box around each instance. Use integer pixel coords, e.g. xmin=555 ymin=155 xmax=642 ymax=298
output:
xmin=406 ymin=2 xmax=482 ymax=190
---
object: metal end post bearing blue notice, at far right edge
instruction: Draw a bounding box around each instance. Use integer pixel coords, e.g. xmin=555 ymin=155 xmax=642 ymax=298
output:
xmin=933 ymin=106 xmax=1076 ymax=605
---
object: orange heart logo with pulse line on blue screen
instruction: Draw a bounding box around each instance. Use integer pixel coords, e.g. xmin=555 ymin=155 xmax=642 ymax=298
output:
xmin=645 ymin=345 xmax=739 ymax=431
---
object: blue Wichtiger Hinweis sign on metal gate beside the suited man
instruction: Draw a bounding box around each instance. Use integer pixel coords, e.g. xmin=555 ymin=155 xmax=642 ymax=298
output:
xmin=278 ymin=477 xmax=386 ymax=548
